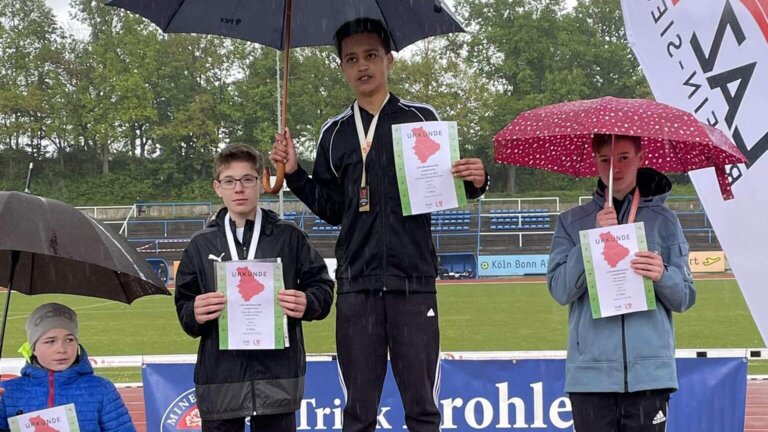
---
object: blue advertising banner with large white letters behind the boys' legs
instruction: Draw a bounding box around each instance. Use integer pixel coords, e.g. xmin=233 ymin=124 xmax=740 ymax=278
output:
xmin=143 ymin=358 xmax=747 ymax=432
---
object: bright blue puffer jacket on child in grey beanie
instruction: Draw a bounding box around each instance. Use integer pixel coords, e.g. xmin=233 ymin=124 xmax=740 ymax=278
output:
xmin=0 ymin=346 xmax=136 ymax=432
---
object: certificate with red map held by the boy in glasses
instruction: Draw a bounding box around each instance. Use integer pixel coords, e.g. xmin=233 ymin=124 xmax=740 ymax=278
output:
xmin=215 ymin=260 xmax=287 ymax=350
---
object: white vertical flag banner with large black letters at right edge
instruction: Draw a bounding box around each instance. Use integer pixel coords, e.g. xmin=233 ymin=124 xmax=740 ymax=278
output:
xmin=621 ymin=0 xmax=768 ymax=343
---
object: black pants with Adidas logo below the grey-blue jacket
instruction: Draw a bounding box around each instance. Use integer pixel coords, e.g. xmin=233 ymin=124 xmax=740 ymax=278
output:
xmin=568 ymin=390 xmax=670 ymax=432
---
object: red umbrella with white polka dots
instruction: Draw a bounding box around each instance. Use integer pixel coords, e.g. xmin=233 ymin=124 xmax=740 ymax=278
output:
xmin=493 ymin=97 xmax=747 ymax=199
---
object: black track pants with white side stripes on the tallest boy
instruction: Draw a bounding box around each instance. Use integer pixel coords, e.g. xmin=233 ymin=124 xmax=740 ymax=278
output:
xmin=336 ymin=292 xmax=440 ymax=432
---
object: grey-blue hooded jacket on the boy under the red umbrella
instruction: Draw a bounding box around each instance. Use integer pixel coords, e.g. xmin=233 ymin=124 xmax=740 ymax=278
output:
xmin=547 ymin=168 xmax=696 ymax=393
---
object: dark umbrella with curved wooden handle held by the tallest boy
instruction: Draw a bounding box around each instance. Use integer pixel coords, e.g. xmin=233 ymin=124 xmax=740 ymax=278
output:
xmin=106 ymin=0 xmax=464 ymax=193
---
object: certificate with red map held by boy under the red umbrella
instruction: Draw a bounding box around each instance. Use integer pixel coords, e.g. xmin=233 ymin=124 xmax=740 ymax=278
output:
xmin=580 ymin=222 xmax=656 ymax=318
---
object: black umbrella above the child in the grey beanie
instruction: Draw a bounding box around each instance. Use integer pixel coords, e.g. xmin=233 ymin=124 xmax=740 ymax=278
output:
xmin=0 ymin=192 xmax=171 ymax=356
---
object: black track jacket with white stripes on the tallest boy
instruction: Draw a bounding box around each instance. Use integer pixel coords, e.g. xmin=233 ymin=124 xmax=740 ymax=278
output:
xmin=286 ymin=95 xmax=488 ymax=294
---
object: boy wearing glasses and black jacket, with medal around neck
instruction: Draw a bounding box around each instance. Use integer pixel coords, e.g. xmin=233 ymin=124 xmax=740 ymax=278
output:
xmin=175 ymin=144 xmax=333 ymax=432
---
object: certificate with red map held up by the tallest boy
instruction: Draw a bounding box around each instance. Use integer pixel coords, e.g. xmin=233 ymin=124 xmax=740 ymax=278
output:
xmin=392 ymin=121 xmax=467 ymax=216
